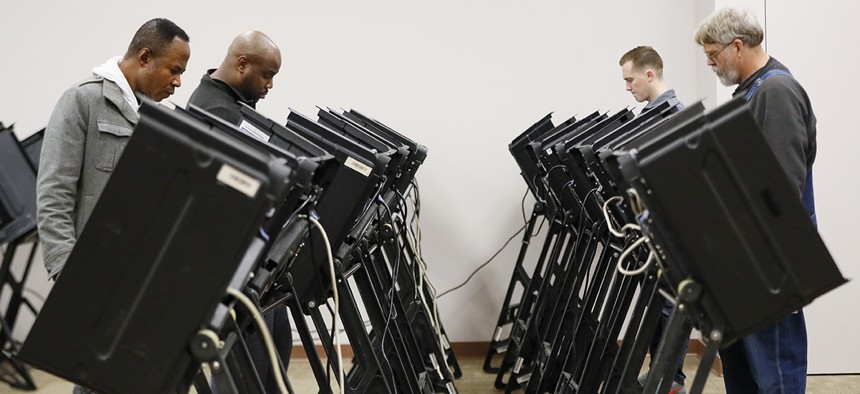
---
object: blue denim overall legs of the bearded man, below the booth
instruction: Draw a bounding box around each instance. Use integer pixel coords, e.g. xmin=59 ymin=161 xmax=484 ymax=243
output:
xmin=720 ymin=311 xmax=806 ymax=394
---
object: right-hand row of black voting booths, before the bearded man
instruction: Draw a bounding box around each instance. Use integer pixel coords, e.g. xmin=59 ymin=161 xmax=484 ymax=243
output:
xmin=484 ymin=98 xmax=845 ymax=394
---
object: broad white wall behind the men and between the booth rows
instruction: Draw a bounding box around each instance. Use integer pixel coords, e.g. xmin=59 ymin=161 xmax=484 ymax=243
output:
xmin=0 ymin=0 xmax=860 ymax=371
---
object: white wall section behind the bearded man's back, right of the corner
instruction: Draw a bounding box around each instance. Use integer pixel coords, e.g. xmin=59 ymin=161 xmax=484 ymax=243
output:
xmin=767 ymin=1 xmax=860 ymax=373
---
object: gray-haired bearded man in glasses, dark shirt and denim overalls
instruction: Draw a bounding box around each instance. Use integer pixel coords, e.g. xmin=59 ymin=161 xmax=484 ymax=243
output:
xmin=694 ymin=8 xmax=816 ymax=394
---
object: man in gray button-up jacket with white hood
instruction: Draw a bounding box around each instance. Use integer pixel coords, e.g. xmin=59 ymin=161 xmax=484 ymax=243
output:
xmin=36 ymin=18 xmax=191 ymax=284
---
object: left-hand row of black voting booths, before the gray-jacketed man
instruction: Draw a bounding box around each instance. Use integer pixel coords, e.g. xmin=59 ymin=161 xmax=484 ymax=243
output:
xmin=19 ymin=102 xmax=460 ymax=393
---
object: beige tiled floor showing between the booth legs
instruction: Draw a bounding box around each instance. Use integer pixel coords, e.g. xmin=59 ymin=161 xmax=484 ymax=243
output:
xmin=6 ymin=356 xmax=860 ymax=394
